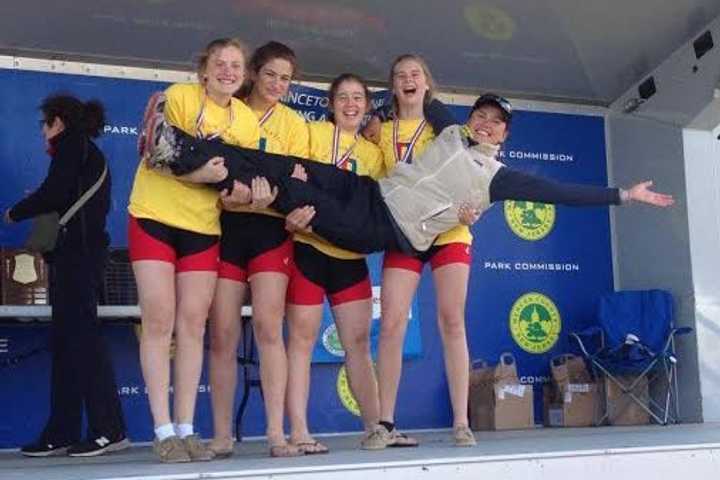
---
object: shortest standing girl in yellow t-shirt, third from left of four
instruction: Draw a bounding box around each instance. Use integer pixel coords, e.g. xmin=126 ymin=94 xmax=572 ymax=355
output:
xmin=287 ymin=74 xmax=384 ymax=454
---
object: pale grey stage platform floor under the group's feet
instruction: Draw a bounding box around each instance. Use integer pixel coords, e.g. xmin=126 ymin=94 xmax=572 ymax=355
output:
xmin=0 ymin=424 xmax=720 ymax=480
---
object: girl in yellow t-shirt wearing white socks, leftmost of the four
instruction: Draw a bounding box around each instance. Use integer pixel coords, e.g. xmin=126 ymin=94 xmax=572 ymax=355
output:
xmin=128 ymin=39 xmax=259 ymax=462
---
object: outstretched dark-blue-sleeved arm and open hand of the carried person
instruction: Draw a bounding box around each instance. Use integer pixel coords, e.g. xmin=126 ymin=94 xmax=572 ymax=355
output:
xmin=490 ymin=167 xmax=674 ymax=207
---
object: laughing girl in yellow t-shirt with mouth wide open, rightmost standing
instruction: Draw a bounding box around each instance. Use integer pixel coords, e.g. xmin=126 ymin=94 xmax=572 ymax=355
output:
xmin=367 ymin=55 xmax=475 ymax=449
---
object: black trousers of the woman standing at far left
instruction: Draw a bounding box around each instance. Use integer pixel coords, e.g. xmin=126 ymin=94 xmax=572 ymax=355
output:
xmin=44 ymin=246 xmax=125 ymax=444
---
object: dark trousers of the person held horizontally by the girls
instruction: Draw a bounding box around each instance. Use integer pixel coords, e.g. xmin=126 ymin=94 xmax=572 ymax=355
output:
xmin=171 ymin=129 xmax=411 ymax=253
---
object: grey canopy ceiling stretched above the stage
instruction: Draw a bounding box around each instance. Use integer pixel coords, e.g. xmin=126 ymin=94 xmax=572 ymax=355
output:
xmin=0 ymin=0 xmax=720 ymax=105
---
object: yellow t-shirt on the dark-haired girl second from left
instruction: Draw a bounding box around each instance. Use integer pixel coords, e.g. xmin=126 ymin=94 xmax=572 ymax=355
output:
xmin=229 ymin=103 xmax=310 ymax=217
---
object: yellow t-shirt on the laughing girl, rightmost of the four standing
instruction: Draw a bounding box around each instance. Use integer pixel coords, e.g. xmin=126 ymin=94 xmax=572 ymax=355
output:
xmin=379 ymin=118 xmax=472 ymax=245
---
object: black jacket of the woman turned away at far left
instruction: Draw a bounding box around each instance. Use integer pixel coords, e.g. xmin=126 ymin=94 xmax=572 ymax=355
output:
xmin=10 ymin=129 xmax=110 ymax=253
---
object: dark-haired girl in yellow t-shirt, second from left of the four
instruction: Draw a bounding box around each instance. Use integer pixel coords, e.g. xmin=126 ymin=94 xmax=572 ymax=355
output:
xmin=210 ymin=42 xmax=308 ymax=457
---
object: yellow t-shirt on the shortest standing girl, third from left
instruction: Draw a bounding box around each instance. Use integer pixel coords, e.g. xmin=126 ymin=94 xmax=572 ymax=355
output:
xmin=294 ymin=122 xmax=385 ymax=260
